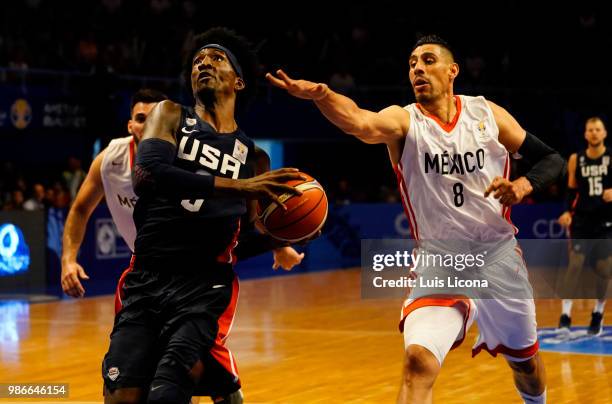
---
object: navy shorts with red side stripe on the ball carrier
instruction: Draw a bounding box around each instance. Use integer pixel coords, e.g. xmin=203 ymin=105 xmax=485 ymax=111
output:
xmin=102 ymin=258 xmax=240 ymax=397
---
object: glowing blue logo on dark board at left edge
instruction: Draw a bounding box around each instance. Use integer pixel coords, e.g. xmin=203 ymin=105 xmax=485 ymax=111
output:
xmin=0 ymin=223 xmax=30 ymax=276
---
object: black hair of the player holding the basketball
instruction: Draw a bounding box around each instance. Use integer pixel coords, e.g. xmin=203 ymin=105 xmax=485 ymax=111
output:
xmin=183 ymin=27 xmax=257 ymax=108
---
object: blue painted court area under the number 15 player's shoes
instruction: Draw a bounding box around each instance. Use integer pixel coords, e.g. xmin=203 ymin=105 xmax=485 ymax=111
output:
xmin=538 ymin=327 xmax=612 ymax=355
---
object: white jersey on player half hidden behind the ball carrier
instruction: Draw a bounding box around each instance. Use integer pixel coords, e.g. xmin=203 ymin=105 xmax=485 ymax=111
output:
xmin=100 ymin=136 xmax=138 ymax=251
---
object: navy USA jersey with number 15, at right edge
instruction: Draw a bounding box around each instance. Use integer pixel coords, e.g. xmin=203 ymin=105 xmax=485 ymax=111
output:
xmin=575 ymin=149 xmax=612 ymax=222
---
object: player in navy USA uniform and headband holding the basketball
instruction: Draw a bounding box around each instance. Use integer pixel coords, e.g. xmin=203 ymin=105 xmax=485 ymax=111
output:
xmin=102 ymin=28 xmax=302 ymax=404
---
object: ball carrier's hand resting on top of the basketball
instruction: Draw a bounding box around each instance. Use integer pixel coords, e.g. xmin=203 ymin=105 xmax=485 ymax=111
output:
xmin=239 ymin=168 xmax=307 ymax=210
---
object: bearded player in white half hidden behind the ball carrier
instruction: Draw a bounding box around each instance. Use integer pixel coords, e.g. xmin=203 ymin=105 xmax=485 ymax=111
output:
xmin=61 ymin=89 xmax=304 ymax=300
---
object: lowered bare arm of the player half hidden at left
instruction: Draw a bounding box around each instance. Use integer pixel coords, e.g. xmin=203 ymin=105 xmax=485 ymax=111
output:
xmin=61 ymin=150 xmax=106 ymax=297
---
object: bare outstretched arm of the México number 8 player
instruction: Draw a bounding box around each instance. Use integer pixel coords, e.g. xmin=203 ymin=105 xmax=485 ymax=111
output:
xmin=266 ymin=70 xmax=410 ymax=144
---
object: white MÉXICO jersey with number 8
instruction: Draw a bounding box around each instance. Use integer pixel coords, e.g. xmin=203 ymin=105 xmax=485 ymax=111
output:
xmin=396 ymin=96 xmax=516 ymax=241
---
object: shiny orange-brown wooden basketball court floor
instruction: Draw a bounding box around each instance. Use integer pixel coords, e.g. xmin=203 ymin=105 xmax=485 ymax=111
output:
xmin=0 ymin=270 xmax=612 ymax=404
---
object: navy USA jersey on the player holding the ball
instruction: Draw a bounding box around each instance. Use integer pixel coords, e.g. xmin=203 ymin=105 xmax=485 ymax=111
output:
xmin=134 ymin=106 xmax=255 ymax=263
